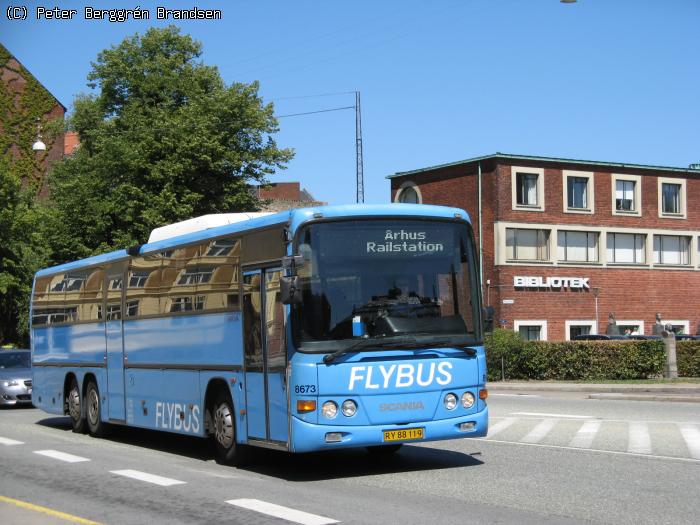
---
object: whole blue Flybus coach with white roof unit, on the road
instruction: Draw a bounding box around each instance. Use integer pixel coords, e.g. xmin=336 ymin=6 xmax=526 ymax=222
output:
xmin=31 ymin=204 xmax=488 ymax=464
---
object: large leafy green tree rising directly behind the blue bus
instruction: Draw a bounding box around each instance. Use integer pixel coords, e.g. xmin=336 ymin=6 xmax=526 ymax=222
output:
xmin=50 ymin=26 xmax=293 ymax=262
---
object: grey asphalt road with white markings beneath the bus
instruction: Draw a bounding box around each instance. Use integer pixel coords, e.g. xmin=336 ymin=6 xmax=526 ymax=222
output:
xmin=0 ymin=393 xmax=700 ymax=525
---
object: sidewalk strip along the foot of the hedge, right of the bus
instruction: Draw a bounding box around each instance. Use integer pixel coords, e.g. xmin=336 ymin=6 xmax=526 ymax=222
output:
xmin=486 ymin=381 xmax=700 ymax=403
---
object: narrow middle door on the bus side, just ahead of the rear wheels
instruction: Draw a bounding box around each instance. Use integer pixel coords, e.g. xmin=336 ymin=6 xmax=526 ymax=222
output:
xmin=105 ymin=263 xmax=126 ymax=420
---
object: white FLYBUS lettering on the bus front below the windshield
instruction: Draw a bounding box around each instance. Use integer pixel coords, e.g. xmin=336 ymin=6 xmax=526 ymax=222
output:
xmin=348 ymin=361 xmax=452 ymax=390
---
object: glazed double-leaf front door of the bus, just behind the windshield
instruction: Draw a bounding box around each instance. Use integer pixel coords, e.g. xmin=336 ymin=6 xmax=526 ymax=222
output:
xmin=243 ymin=268 xmax=289 ymax=444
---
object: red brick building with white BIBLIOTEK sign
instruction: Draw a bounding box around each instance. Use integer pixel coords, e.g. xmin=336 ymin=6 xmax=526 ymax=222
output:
xmin=388 ymin=153 xmax=700 ymax=340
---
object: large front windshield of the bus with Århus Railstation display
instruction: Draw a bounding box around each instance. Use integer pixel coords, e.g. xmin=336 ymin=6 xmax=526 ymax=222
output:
xmin=294 ymin=219 xmax=480 ymax=351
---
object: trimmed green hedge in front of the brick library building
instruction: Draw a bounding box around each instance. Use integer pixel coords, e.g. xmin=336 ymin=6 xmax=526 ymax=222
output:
xmin=486 ymin=329 xmax=680 ymax=381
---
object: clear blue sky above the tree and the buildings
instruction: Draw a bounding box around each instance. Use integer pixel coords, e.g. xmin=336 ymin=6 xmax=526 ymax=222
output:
xmin=0 ymin=0 xmax=700 ymax=204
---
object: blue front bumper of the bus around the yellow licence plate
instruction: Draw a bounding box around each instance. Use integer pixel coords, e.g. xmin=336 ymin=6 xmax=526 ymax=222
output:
xmin=291 ymin=407 xmax=489 ymax=452
